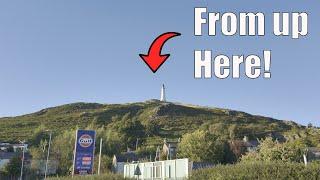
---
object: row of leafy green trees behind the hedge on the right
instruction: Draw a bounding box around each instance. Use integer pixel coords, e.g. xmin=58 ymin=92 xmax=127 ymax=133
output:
xmin=179 ymin=130 xmax=316 ymax=164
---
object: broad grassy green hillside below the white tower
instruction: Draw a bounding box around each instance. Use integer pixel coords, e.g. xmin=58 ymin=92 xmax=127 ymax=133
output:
xmin=0 ymin=100 xmax=304 ymax=142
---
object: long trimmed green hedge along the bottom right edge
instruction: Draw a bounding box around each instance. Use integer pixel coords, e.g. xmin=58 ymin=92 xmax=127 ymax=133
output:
xmin=190 ymin=162 xmax=320 ymax=180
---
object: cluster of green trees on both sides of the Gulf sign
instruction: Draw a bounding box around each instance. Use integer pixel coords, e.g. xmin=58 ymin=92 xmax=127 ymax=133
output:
xmin=25 ymin=114 xmax=156 ymax=175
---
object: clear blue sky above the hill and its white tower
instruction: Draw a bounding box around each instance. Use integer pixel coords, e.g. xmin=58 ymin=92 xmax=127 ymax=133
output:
xmin=0 ymin=0 xmax=320 ymax=126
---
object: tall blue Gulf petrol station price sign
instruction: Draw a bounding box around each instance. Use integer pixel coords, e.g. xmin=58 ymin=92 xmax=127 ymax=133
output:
xmin=74 ymin=130 xmax=96 ymax=175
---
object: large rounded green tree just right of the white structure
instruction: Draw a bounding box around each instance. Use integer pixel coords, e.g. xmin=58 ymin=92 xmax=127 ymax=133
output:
xmin=178 ymin=130 xmax=225 ymax=163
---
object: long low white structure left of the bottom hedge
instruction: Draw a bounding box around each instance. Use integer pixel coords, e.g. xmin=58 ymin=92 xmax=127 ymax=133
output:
xmin=124 ymin=159 xmax=192 ymax=180
